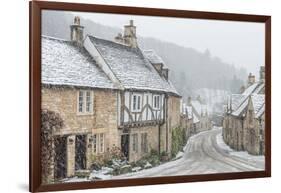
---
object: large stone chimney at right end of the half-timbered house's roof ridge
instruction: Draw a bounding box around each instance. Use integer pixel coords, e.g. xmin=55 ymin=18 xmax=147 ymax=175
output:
xmin=124 ymin=20 xmax=138 ymax=48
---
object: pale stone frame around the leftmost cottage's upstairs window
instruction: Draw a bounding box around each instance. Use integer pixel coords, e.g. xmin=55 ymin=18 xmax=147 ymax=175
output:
xmin=77 ymin=90 xmax=94 ymax=115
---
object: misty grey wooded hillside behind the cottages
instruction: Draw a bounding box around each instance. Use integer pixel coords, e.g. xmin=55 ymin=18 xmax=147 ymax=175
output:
xmin=42 ymin=11 xmax=246 ymax=99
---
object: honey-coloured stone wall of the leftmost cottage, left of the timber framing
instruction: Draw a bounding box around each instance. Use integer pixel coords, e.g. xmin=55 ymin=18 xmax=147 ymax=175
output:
xmin=42 ymin=88 xmax=117 ymax=180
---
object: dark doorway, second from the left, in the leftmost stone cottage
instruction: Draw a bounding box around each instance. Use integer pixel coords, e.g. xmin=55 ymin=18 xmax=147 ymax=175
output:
xmin=75 ymin=135 xmax=86 ymax=170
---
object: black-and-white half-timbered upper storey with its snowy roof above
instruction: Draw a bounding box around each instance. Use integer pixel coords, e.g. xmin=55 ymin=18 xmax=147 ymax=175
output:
xmin=85 ymin=36 xmax=179 ymax=128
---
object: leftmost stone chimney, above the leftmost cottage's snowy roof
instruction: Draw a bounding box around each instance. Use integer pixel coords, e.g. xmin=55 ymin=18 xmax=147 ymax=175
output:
xmin=70 ymin=16 xmax=84 ymax=46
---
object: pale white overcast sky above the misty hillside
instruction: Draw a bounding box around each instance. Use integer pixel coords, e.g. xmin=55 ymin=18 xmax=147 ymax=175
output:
xmin=71 ymin=12 xmax=265 ymax=77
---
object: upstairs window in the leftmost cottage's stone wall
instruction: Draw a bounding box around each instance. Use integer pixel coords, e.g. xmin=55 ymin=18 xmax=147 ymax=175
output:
xmin=78 ymin=91 xmax=93 ymax=113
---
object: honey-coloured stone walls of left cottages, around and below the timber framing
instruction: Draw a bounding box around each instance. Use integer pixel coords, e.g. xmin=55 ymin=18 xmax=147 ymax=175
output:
xmin=42 ymin=87 xmax=180 ymax=182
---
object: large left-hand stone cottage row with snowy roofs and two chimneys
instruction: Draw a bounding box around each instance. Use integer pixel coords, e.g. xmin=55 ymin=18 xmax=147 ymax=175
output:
xmin=41 ymin=17 xmax=181 ymax=182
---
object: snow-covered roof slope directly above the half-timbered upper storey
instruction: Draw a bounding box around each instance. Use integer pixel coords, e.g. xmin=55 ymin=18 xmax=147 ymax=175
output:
xmin=88 ymin=36 xmax=179 ymax=96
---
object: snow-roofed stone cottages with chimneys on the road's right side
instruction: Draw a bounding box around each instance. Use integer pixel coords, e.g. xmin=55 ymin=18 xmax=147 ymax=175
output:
xmin=223 ymin=67 xmax=265 ymax=154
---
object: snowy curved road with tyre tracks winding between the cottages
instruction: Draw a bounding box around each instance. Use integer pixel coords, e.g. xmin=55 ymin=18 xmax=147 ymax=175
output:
xmin=113 ymin=128 xmax=264 ymax=178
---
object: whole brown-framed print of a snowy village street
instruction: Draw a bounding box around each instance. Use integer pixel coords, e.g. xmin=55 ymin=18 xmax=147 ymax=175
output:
xmin=30 ymin=1 xmax=271 ymax=192
